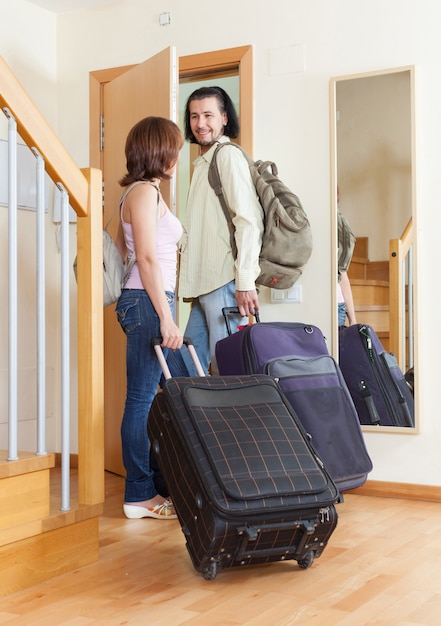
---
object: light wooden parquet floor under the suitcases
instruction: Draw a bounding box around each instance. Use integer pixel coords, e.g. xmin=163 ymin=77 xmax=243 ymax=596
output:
xmin=0 ymin=474 xmax=441 ymax=626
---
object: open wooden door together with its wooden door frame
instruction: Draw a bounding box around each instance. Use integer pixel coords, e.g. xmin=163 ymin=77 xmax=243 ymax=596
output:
xmin=89 ymin=46 xmax=253 ymax=476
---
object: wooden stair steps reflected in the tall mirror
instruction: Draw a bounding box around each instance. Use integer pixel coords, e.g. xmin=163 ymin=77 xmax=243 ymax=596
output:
xmin=348 ymin=237 xmax=389 ymax=350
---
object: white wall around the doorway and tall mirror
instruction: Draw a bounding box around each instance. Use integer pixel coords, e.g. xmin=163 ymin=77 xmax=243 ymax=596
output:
xmin=0 ymin=0 xmax=441 ymax=485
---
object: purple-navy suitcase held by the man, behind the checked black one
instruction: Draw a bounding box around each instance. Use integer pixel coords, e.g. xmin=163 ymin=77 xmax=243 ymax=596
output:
xmin=216 ymin=308 xmax=372 ymax=491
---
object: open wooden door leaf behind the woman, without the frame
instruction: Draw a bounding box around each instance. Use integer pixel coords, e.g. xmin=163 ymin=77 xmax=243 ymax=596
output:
xmin=102 ymin=48 xmax=177 ymax=475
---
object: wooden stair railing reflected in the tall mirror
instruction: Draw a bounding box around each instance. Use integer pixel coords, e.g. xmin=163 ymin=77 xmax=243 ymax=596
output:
xmin=389 ymin=218 xmax=413 ymax=371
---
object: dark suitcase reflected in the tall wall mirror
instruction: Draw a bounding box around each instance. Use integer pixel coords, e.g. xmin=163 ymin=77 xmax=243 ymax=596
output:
xmin=339 ymin=324 xmax=415 ymax=428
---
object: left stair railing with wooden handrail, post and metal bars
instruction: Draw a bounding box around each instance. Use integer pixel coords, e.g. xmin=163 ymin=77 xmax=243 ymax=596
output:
xmin=0 ymin=57 xmax=104 ymax=510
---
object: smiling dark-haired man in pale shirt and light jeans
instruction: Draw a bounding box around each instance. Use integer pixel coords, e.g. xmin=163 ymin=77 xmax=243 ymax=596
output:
xmin=179 ymin=87 xmax=263 ymax=374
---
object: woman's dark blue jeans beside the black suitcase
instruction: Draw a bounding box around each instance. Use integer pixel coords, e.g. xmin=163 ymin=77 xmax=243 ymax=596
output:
xmin=116 ymin=289 xmax=174 ymax=502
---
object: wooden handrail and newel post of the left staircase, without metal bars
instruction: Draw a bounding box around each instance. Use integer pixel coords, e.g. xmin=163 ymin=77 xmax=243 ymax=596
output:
xmin=0 ymin=56 xmax=104 ymax=505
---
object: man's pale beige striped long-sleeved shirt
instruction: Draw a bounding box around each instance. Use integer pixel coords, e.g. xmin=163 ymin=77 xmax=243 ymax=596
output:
xmin=179 ymin=137 xmax=263 ymax=298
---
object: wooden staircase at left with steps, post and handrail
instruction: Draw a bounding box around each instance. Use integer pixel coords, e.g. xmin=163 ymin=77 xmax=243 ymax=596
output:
xmin=0 ymin=56 xmax=105 ymax=596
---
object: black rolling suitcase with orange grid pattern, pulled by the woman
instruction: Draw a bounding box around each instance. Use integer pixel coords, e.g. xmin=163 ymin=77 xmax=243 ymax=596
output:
xmin=148 ymin=338 xmax=339 ymax=580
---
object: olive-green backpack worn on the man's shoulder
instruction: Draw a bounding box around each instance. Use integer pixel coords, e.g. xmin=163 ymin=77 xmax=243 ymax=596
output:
xmin=208 ymin=142 xmax=312 ymax=289
